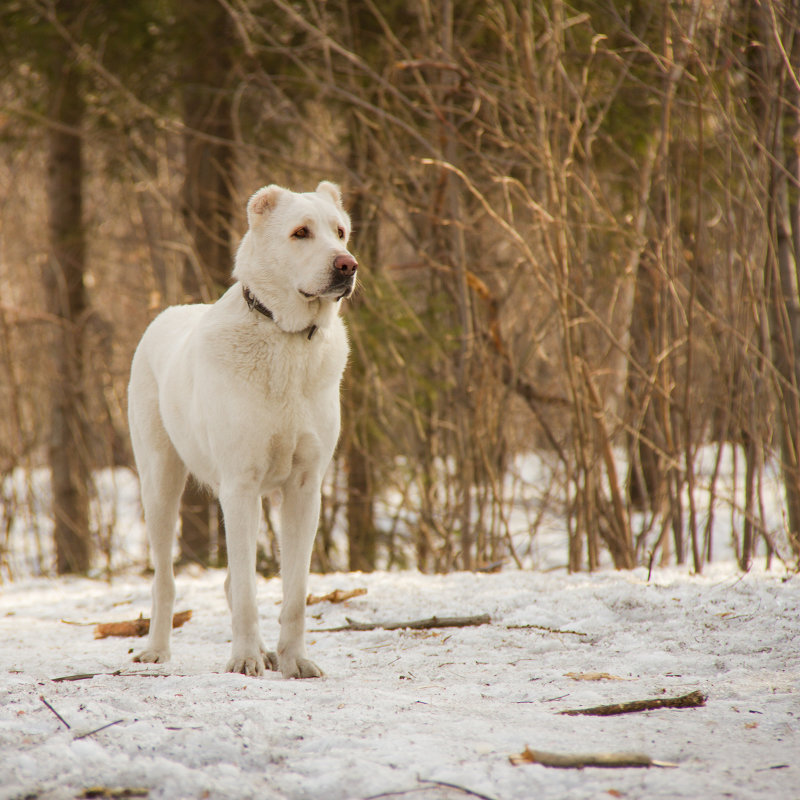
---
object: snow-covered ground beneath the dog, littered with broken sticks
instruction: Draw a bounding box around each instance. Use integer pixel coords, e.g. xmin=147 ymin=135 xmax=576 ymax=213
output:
xmin=0 ymin=564 xmax=800 ymax=800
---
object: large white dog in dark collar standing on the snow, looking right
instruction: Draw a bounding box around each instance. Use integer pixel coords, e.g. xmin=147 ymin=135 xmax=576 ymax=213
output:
xmin=128 ymin=181 xmax=358 ymax=678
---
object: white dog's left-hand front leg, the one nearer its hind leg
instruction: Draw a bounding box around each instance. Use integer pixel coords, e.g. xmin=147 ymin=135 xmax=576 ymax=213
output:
xmin=219 ymin=488 xmax=265 ymax=675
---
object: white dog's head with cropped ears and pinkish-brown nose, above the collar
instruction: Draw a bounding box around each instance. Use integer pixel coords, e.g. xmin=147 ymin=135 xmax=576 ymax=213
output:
xmin=234 ymin=181 xmax=358 ymax=312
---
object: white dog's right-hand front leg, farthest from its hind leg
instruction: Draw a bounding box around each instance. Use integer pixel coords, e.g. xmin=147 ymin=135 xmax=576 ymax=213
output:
xmin=278 ymin=480 xmax=323 ymax=678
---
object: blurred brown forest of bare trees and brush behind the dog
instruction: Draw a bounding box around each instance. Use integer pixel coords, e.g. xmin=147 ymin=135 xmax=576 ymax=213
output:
xmin=0 ymin=0 xmax=800 ymax=576
